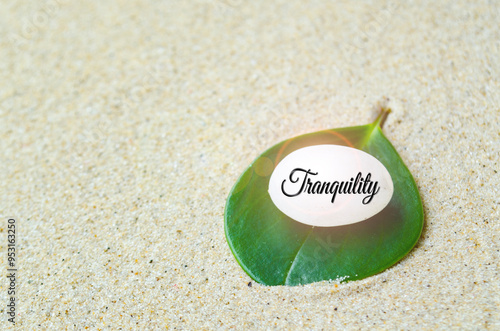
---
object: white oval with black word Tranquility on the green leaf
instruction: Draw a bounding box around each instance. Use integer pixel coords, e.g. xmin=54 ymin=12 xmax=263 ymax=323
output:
xmin=269 ymin=145 xmax=394 ymax=227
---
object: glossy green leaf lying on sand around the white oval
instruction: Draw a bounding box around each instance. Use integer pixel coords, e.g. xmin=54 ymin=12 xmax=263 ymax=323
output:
xmin=225 ymin=109 xmax=423 ymax=286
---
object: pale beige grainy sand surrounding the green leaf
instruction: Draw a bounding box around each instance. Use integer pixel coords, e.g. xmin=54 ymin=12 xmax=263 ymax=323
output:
xmin=0 ymin=0 xmax=500 ymax=330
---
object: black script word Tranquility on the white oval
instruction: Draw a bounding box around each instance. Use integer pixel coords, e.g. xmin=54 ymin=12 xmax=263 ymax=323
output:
xmin=281 ymin=168 xmax=380 ymax=205
